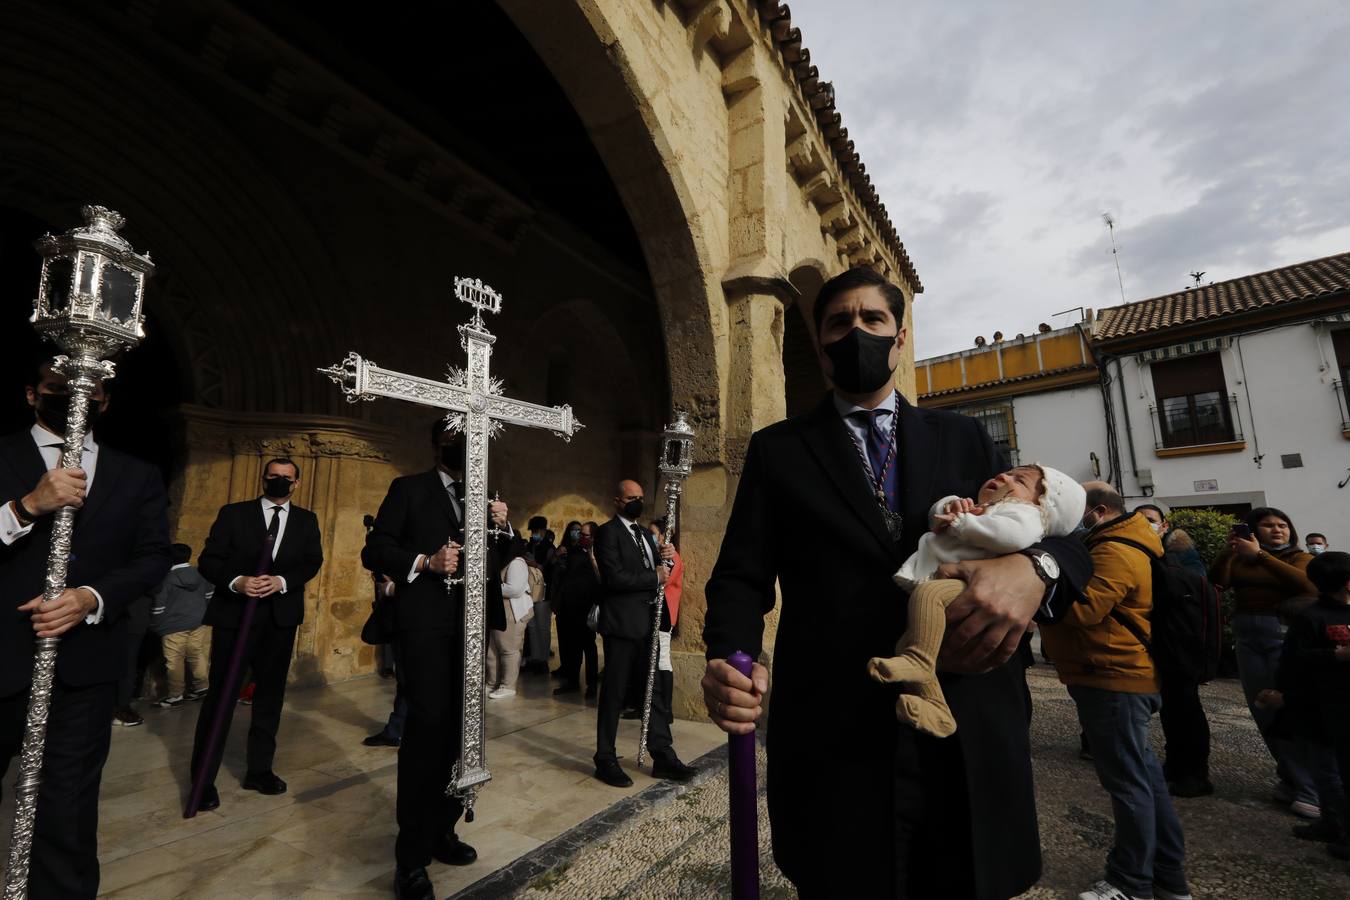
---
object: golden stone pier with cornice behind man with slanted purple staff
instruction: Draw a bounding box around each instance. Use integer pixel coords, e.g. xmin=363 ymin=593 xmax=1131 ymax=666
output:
xmin=169 ymin=405 xmax=400 ymax=684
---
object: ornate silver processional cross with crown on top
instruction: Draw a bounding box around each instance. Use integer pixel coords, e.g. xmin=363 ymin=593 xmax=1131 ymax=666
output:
xmin=326 ymin=278 xmax=582 ymax=822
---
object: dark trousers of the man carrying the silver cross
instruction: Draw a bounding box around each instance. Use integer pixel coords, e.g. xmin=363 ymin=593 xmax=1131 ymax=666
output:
xmin=394 ymin=631 xmax=464 ymax=869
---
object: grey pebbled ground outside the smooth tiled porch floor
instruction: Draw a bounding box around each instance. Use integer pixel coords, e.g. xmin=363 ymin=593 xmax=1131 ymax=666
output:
xmin=480 ymin=667 xmax=1350 ymax=900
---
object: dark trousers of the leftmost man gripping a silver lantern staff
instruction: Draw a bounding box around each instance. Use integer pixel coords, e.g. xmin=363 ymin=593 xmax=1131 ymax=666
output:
xmin=0 ymin=680 xmax=116 ymax=900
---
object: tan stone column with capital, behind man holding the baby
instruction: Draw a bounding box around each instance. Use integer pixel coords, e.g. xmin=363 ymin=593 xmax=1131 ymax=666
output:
xmin=672 ymin=275 xmax=797 ymax=718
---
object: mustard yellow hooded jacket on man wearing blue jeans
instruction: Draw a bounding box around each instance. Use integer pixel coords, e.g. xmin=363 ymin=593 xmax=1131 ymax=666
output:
xmin=1041 ymin=513 xmax=1162 ymax=694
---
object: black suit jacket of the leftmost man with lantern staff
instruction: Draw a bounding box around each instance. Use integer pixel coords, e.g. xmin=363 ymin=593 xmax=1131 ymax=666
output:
xmin=0 ymin=430 xmax=169 ymax=696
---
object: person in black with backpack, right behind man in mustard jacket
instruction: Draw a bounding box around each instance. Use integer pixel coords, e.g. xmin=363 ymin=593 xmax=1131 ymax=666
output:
xmin=1135 ymin=503 xmax=1223 ymax=797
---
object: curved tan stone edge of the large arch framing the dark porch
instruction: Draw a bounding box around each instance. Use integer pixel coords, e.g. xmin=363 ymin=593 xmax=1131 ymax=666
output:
xmin=498 ymin=0 xmax=725 ymax=461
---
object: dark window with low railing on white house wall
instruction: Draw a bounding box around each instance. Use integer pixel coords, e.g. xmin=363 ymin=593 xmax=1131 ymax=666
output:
xmin=1150 ymin=354 xmax=1235 ymax=447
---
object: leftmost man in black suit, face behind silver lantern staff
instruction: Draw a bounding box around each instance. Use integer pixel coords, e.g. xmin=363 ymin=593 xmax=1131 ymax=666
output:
xmin=0 ymin=364 xmax=169 ymax=900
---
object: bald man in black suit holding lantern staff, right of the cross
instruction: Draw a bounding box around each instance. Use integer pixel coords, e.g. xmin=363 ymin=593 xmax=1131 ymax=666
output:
xmin=594 ymin=482 xmax=694 ymax=788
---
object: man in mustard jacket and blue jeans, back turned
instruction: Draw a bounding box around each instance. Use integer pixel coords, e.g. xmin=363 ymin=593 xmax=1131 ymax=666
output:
xmin=1041 ymin=482 xmax=1191 ymax=900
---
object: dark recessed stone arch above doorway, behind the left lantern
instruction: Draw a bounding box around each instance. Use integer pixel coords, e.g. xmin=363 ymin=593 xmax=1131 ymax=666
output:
xmin=0 ymin=3 xmax=352 ymax=410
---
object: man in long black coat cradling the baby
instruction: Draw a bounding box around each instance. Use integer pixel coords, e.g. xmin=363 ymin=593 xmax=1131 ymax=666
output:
xmin=703 ymin=269 xmax=1091 ymax=900
